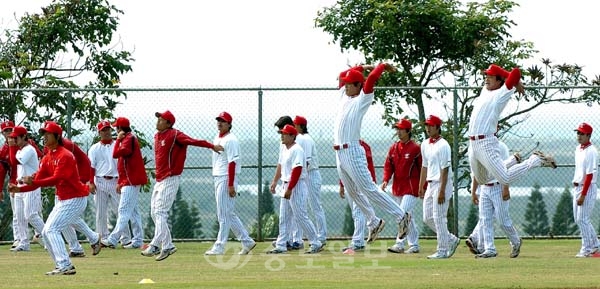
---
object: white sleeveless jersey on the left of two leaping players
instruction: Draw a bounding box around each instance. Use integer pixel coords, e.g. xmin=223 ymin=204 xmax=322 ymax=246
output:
xmin=333 ymin=87 xmax=375 ymax=145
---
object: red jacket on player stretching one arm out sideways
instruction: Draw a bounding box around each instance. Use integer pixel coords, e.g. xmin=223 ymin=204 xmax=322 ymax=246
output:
xmin=154 ymin=128 xmax=214 ymax=182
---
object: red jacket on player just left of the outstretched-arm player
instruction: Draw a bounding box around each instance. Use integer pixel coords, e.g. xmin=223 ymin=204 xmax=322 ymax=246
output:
xmin=114 ymin=132 xmax=148 ymax=186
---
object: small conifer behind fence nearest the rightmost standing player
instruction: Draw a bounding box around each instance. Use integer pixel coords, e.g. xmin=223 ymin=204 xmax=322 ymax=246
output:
xmin=550 ymin=185 xmax=578 ymax=236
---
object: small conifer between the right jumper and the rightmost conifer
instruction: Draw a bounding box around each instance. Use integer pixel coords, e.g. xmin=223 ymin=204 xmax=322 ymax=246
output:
xmin=523 ymin=183 xmax=550 ymax=236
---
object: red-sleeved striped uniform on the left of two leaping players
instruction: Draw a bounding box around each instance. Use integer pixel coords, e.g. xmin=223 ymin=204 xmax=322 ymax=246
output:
xmin=333 ymin=64 xmax=405 ymax=229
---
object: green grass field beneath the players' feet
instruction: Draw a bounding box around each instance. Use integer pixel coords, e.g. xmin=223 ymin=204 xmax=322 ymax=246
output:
xmin=0 ymin=240 xmax=600 ymax=288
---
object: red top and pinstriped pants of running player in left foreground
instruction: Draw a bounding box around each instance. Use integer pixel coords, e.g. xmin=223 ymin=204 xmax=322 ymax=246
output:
xmin=21 ymin=146 xmax=99 ymax=269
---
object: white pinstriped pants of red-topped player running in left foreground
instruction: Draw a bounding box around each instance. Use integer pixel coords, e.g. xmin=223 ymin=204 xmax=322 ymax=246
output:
xmin=42 ymin=197 xmax=99 ymax=268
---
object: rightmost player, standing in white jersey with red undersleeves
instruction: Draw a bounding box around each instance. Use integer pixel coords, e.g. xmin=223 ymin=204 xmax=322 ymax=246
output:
xmin=573 ymin=122 xmax=600 ymax=258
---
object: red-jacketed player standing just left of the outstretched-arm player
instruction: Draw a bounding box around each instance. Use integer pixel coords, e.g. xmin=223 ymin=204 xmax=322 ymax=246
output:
xmin=101 ymin=117 xmax=148 ymax=248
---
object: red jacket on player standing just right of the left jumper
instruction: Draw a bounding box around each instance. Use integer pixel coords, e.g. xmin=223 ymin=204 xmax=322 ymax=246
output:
xmin=383 ymin=140 xmax=422 ymax=197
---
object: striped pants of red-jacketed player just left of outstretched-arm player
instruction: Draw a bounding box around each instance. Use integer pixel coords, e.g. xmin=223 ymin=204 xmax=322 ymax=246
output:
xmin=107 ymin=185 xmax=144 ymax=246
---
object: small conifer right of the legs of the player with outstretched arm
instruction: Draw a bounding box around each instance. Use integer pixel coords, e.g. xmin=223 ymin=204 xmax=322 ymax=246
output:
xmin=169 ymin=188 xmax=203 ymax=239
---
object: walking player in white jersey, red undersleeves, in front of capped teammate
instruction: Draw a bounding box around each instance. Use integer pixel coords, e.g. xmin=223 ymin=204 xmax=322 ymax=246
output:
xmin=267 ymin=124 xmax=323 ymax=254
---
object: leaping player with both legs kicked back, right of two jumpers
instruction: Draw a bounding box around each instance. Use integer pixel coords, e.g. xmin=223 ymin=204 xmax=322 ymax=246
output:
xmin=469 ymin=64 xmax=556 ymax=189
